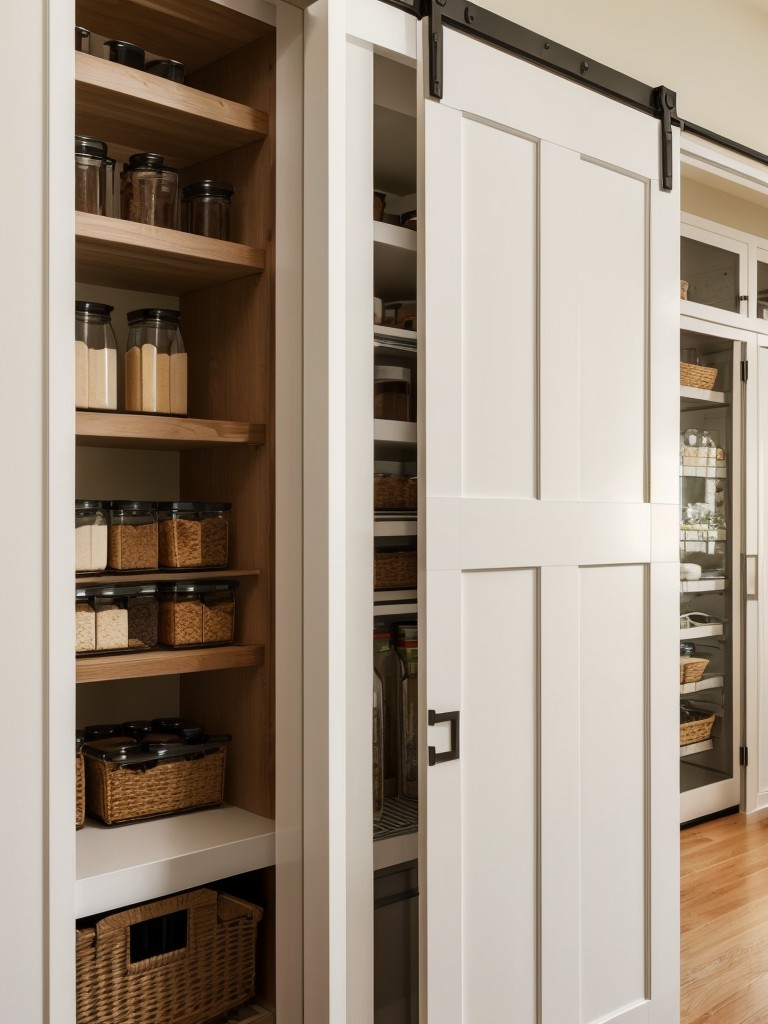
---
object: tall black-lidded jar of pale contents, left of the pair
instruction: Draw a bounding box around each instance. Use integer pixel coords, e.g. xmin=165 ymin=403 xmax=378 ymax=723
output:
xmin=75 ymin=300 xmax=118 ymax=412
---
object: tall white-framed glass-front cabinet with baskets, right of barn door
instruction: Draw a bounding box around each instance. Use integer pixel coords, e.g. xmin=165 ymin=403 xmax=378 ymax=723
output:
xmin=680 ymin=317 xmax=744 ymax=821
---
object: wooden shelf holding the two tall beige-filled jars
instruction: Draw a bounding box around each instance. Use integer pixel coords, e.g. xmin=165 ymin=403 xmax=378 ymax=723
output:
xmin=75 ymin=412 xmax=266 ymax=452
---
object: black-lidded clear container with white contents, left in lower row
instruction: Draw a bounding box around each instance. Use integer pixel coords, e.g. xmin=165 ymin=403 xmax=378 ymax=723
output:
xmin=76 ymin=584 xmax=158 ymax=654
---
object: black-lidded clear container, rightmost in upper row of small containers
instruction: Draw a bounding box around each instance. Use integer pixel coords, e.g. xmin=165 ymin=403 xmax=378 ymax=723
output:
xmin=157 ymin=502 xmax=231 ymax=569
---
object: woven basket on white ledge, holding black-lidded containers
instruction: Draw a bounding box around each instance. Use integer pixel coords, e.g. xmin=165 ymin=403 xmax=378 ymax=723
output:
xmin=85 ymin=748 xmax=226 ymax=825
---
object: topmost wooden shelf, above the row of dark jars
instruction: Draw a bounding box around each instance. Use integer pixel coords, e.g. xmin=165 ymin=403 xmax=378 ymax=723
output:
xmin=75 ymin=53 xmax=268 ymax=167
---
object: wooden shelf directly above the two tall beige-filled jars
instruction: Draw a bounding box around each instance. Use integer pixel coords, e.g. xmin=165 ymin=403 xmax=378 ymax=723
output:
xmin=75 ymin=212 xmax=264 ymax=295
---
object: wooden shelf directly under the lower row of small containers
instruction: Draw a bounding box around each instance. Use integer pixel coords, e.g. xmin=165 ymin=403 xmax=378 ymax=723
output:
xmin=76 ymin=644 xmax=264 ymax=683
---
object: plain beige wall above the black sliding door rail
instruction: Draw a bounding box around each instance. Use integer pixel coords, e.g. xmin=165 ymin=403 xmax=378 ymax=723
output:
xmin=480 ymin=0 xmax=768 ymax=153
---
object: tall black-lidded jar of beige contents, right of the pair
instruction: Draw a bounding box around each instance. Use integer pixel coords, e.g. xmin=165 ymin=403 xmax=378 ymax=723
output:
xmin=125 ymin=309 xmax=186 ymax=416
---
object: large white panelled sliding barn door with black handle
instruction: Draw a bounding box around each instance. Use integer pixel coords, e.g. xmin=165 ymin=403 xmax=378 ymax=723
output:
xmin=419 ymin=24 xmax=679 ymax=1024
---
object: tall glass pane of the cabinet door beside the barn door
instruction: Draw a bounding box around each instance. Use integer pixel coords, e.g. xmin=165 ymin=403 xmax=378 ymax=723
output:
xmin=680 ymin=331 xmax=739 ymax=792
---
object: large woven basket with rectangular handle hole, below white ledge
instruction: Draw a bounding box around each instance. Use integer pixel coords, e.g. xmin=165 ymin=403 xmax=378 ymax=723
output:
xmin=76 ymin=889 xmax=263 ymax=1024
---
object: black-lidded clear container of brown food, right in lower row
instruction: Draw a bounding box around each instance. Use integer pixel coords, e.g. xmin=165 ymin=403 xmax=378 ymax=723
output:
xmin=159 ymin=580 xmax=239 ymax=647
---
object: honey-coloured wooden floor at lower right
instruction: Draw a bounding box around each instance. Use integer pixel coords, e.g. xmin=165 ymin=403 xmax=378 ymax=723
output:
xmin=680 ymin=814 xmax=768 ymax=1024
